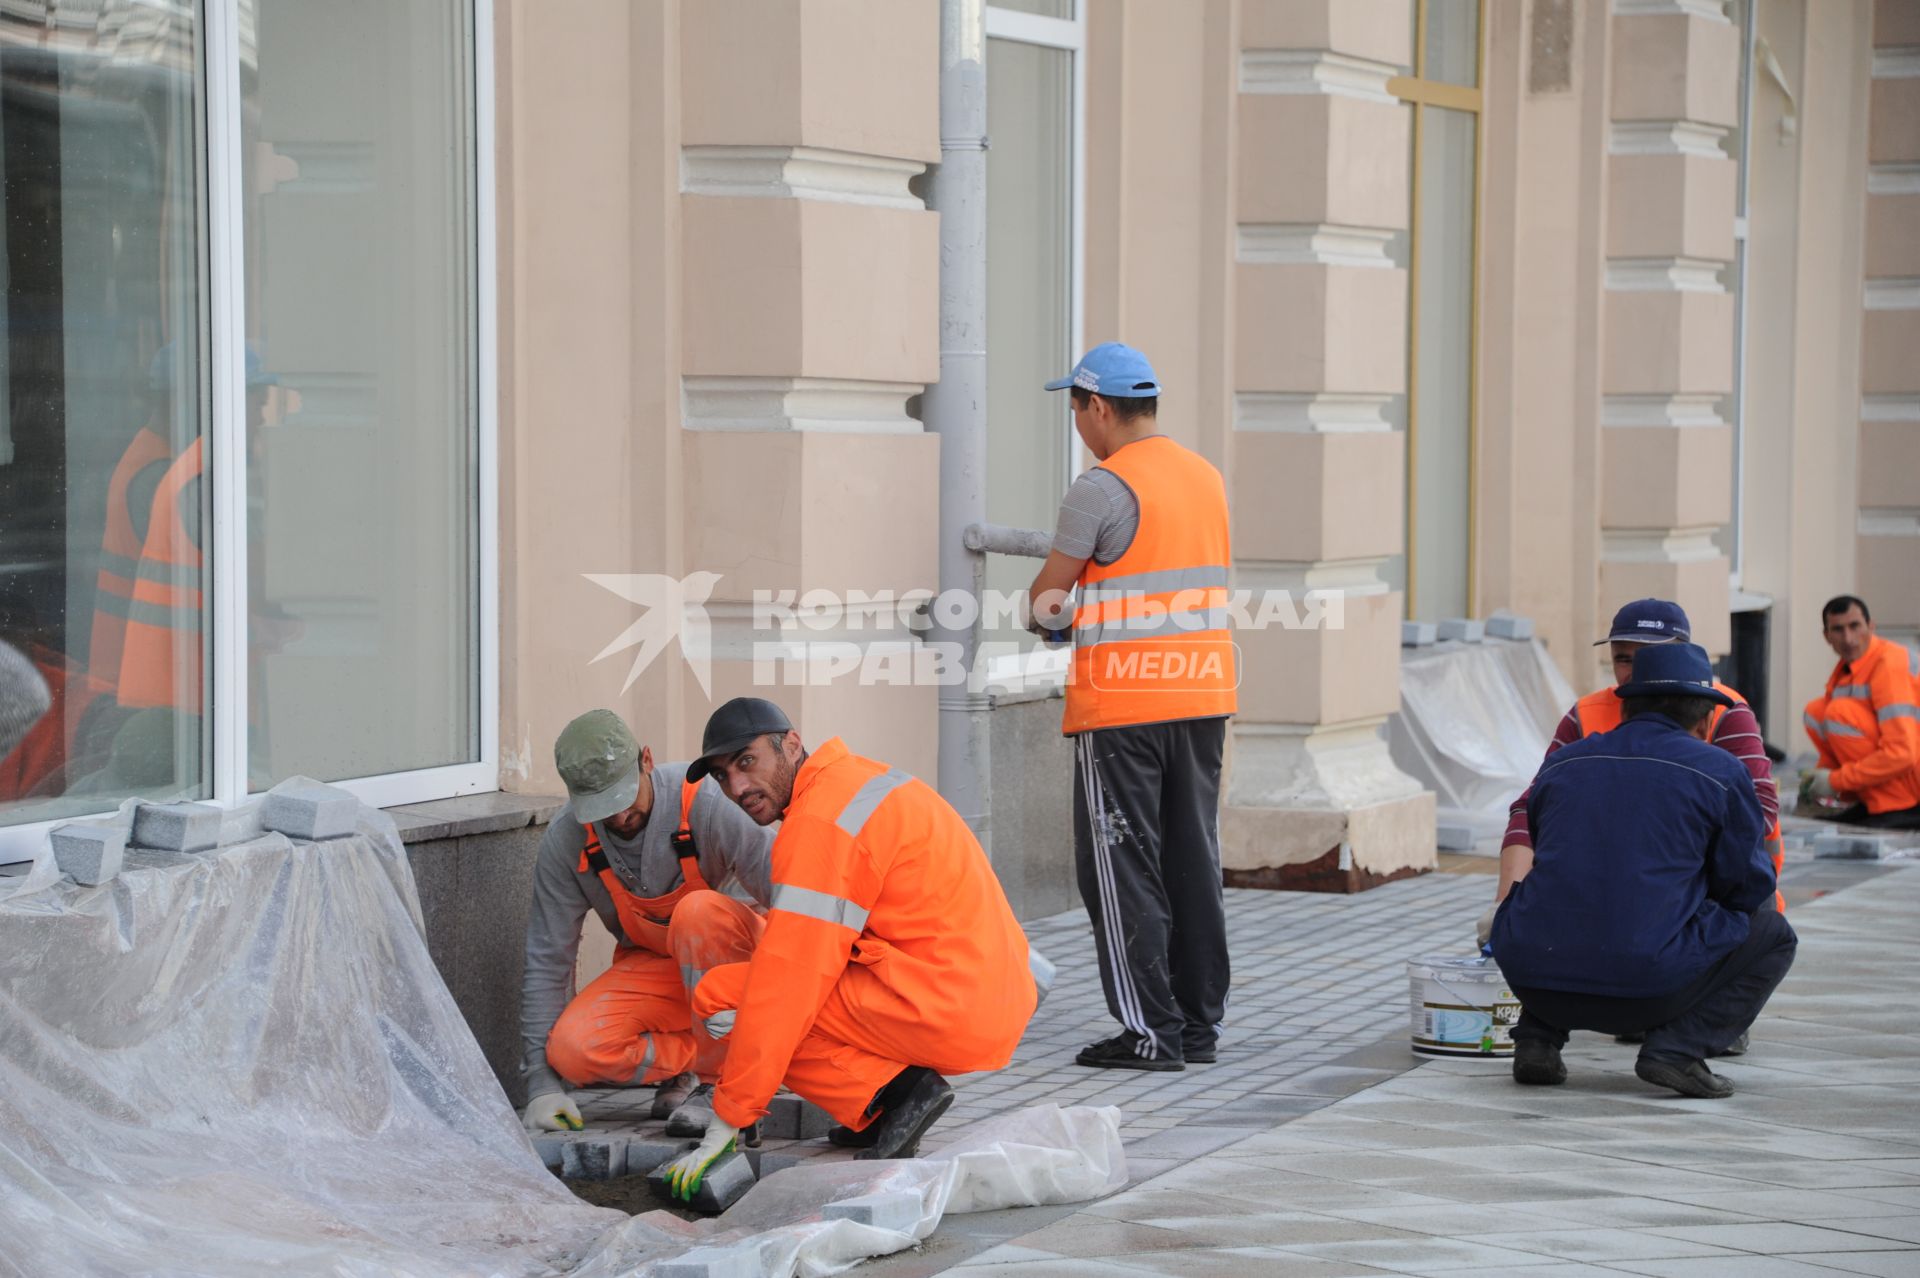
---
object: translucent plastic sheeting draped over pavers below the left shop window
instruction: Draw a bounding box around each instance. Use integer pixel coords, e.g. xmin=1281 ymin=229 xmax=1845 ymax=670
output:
xmin=0 ymin=790 xmax=1125 ymax=1278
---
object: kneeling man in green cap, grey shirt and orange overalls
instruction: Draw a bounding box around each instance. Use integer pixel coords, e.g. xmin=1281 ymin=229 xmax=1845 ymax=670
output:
xmin=520 ymin=710 xmax=772 ymax=1132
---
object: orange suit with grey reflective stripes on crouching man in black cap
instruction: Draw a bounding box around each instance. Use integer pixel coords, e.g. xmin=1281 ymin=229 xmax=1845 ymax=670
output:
xmin=714 ymin=737 xmax=1037 ymax=1126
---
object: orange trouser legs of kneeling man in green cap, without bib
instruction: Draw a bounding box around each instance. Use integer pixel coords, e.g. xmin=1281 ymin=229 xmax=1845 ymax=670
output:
xmin=547 ymin=890 xmax=766 ymax=1088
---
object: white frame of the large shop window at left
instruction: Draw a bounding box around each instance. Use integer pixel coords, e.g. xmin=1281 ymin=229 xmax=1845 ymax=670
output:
xmin=0 ymin=0 xmax=499 ymax=862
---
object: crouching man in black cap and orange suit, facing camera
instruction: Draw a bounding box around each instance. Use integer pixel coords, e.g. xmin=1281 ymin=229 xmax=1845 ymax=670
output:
xmin=668 ymin=697 xmax=1037 ymax=1192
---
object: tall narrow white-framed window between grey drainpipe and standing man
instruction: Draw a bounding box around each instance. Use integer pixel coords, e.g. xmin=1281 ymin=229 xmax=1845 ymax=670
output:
xmin=983 ymin=0 xmax=1085 ymax=649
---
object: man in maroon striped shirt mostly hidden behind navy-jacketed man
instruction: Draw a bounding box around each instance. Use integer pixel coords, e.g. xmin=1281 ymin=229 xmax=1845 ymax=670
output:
xmin=1482 ymin=599 xmax=1788 ymax=917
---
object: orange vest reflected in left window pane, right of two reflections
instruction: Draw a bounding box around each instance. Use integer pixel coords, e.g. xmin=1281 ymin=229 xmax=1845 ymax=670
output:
xmin=119 ymin=439 xmax=205 ymax=714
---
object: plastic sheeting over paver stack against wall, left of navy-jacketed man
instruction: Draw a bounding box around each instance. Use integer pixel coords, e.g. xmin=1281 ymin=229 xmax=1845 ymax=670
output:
xmin=1386 ymin=639 xmax=1574 ymax=839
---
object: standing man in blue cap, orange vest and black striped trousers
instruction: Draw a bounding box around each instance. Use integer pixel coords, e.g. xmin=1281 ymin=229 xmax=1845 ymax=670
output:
xmin=1029 ymin=342 xmax=1238 ymax=1071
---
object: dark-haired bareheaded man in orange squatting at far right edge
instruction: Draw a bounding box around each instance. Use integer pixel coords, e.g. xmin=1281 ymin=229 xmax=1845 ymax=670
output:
xmin=1801 ymin=595 xmax=1920 ymax=829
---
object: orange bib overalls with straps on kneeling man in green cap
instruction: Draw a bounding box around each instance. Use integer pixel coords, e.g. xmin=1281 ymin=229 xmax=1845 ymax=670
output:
xmin=547 ymin=781 xmax=766 ymax=1086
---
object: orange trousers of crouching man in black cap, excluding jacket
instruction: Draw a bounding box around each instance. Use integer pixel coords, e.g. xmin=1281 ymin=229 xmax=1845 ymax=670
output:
xmin=693 ymin=963 xmax=947 ymax=1132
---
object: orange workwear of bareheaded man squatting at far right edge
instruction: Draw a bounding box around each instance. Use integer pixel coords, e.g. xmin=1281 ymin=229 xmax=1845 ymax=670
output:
xmin=1805 ymin=635 xmax=1920 ymax=812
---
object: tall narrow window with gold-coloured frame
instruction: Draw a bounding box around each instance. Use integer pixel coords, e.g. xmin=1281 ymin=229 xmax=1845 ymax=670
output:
xmin=1388 ymin=0 xmax=1482 ymax=620
